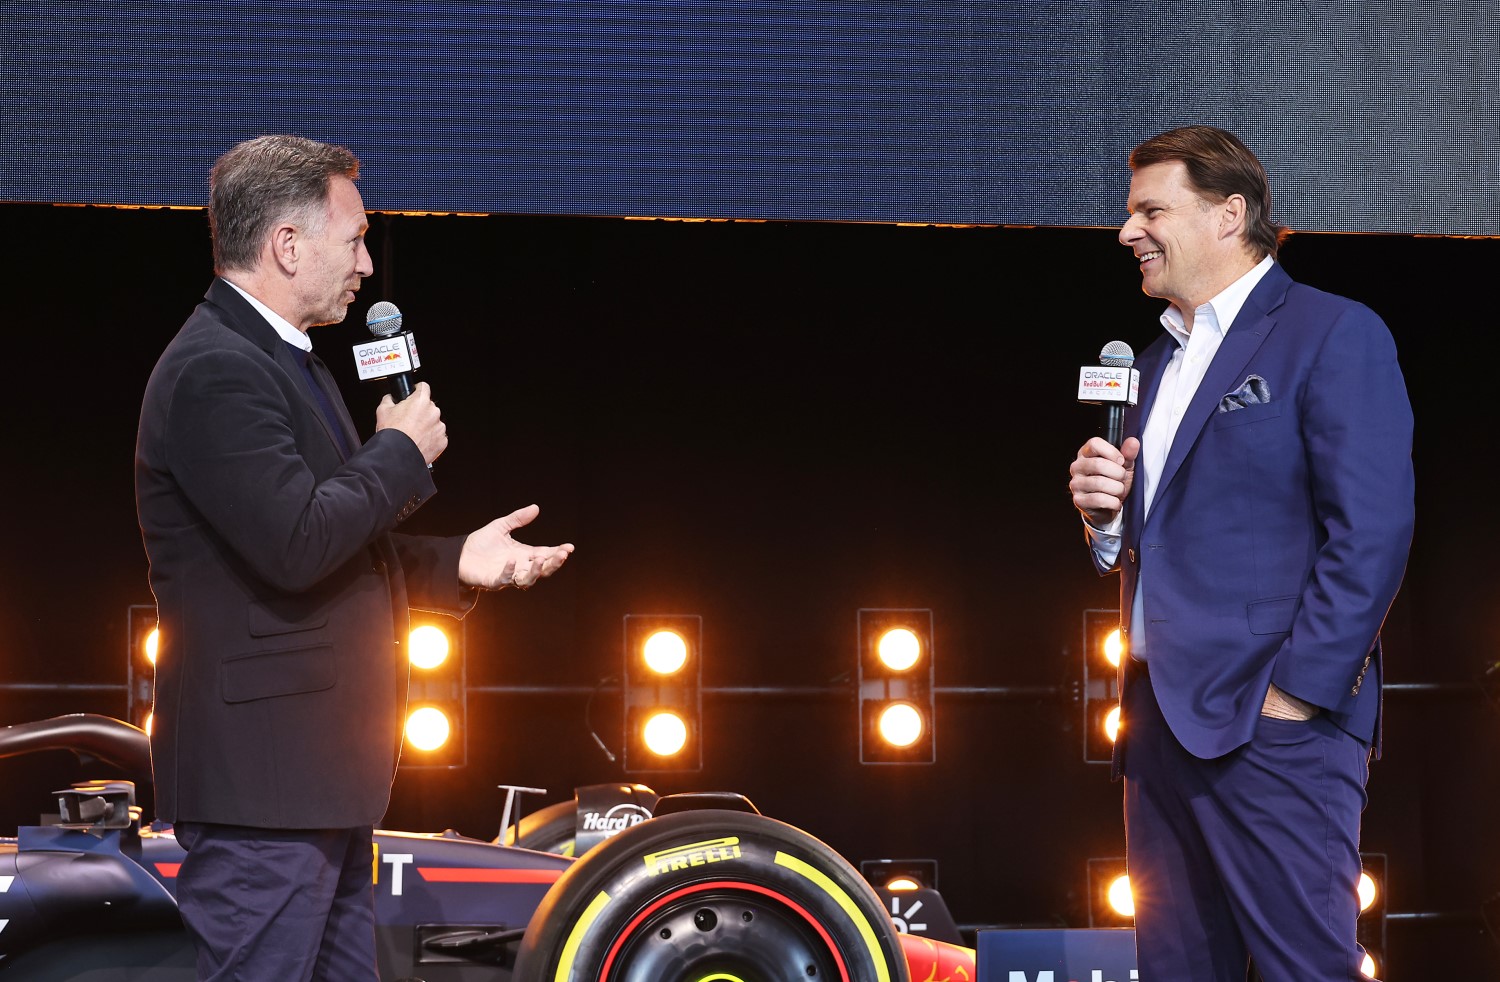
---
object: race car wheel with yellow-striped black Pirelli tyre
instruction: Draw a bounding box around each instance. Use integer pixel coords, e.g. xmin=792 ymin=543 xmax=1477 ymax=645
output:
xmin=513 ymin=810 xmax=909 ymax=982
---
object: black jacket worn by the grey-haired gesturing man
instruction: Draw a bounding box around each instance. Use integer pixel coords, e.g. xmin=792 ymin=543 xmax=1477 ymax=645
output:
xmin=135 ymin=280 xmax=474 ymax=828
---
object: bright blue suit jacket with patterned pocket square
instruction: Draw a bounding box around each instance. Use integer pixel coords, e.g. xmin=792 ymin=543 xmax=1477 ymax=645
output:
xmin=1116 ymin=265 xmax=1413 ymax=766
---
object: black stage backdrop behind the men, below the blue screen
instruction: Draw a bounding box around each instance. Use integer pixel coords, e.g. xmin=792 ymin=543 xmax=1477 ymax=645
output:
xmin=0 ymin=203 xmax=1500 ymax=979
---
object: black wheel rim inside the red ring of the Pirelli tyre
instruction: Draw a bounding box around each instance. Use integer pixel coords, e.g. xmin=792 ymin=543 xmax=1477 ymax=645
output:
xmin=599 ymin=880 xmax=849 ymax=982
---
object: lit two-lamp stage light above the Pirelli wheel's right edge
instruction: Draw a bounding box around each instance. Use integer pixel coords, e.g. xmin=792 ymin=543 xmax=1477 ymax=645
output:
xmin=857 ymin=609 xmax=938 ymax=763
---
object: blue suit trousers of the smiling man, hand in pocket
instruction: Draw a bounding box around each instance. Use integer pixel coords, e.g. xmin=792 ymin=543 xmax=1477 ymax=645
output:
xmin=1122 ymin=672 xmax=1370 ymax=982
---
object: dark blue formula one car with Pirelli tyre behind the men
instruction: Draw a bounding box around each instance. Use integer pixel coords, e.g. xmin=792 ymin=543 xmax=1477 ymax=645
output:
xmin=0 ymin=715 xmax=974 ymax=982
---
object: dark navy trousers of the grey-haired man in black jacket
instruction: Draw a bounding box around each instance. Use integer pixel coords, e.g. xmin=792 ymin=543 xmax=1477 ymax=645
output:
xmin=176 ymin=822 xmax=377 ymax=982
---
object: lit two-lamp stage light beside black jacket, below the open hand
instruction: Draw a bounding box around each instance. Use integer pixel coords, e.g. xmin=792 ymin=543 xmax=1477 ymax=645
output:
xmin=401 ymin=610 xmax=468 ymax=768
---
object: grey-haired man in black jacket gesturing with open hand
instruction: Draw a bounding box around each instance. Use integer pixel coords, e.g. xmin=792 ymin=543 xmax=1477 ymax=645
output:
xmin=135 ymin=136 xmax=573 ymax=982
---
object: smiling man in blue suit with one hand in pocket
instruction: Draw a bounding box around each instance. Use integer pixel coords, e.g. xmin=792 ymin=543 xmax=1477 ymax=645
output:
xmin=1070 ymin=126 xmax=1413 ymax=982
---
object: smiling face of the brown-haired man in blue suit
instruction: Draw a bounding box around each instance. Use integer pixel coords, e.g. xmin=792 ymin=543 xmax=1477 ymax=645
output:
xmin=1121 ymin=160 xmax=1238 ymax=312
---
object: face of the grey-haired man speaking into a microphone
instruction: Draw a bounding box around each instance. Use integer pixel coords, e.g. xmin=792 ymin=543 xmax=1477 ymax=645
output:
xmin=294 ymin=177 xmax=375 ymax=330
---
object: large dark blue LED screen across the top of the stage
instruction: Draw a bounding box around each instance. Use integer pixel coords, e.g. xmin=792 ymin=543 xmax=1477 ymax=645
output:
xmin=0 ymin=0 xmax=1500 ymax=235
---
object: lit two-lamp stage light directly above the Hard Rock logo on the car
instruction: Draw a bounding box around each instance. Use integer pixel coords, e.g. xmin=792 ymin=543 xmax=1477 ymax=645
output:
xmin=623 ymin=613 xmax=704 ymax=774
